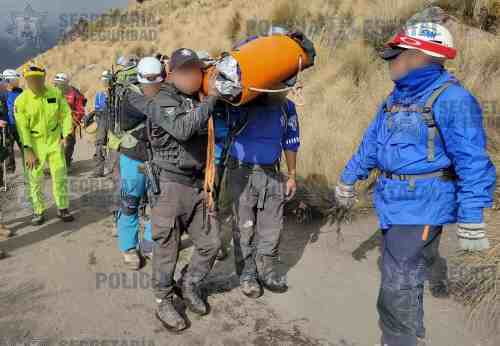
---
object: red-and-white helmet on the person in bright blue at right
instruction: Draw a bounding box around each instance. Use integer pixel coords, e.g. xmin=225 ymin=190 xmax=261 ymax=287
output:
xmin=387 ymin=22 xmax=457 ymax=59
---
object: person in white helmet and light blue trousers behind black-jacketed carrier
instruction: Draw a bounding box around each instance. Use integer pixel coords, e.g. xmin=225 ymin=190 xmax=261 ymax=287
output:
xmin=116 ymin=57 xmax=156 ymax=270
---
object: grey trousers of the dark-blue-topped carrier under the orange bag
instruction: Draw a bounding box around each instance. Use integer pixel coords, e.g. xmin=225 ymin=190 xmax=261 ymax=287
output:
xmin=228 ymin=162 xmax=285 ymax=281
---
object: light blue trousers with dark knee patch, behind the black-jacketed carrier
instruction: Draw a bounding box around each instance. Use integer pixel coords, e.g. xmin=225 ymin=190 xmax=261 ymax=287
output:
xmin=117 ymin=155 xmax=152 ymax=252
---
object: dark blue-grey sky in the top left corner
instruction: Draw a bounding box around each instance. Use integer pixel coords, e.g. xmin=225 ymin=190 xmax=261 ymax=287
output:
xmin=0 ymin=0 xmax=129 ymax=71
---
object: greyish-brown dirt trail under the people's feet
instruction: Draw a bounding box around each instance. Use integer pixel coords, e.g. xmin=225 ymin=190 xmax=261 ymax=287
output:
xmin=0 ymin=141 xmax=487 ymax=346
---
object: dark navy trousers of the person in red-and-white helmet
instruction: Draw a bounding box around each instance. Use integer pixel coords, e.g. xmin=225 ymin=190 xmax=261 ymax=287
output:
xmin=377 ymin=225 xmax=442 ymax=346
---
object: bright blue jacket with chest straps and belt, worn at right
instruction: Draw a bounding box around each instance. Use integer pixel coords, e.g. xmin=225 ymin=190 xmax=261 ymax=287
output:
xmin=341 ymin=64 xmax=496 ymax=229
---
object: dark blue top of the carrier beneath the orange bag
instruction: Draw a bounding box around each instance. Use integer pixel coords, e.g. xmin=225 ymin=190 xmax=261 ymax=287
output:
xmin=228 ymin=96 xmax=300 ymax=165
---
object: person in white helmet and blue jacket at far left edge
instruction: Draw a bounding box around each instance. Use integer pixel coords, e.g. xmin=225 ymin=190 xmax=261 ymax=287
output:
xmin=2 ymin=69 xmax=24 ymax=173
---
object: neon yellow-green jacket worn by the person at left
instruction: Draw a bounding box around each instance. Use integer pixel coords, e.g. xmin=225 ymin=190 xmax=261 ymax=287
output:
xmin=15 ymin=86 xmax=73 ymax=159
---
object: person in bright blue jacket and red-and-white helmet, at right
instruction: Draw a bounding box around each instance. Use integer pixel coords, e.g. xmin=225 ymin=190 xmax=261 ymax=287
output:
xmin=335 ymin=23 xmax=496 ymax=346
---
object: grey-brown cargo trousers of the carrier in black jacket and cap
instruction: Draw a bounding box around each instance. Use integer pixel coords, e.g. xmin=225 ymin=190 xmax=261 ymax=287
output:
xmin=151 ymin=174 xmax=221 ymax=299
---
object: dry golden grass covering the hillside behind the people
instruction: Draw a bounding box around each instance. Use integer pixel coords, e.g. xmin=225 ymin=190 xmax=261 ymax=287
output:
xmin=31 ymin=0 xmax=500 ymax=185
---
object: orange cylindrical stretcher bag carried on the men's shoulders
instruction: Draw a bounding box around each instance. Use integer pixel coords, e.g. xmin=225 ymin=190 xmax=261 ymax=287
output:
xmin=203 ymin=35 xmax=315 ymax=106
